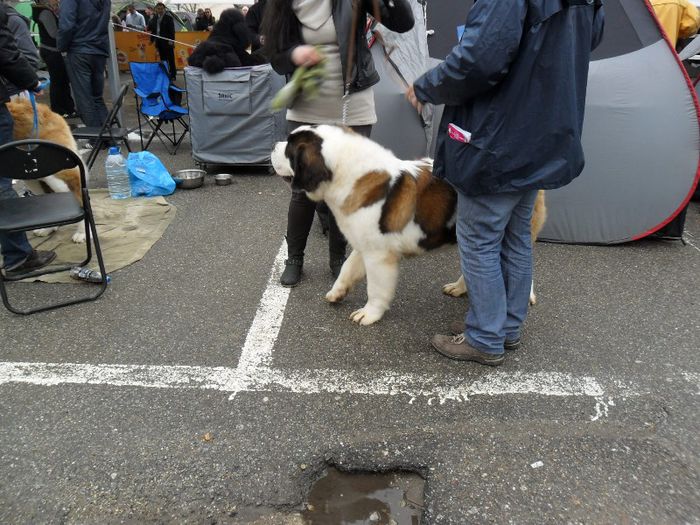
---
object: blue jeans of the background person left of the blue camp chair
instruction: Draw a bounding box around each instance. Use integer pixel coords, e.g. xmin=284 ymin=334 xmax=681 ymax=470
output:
xmin=66 ymin=52 xmax=108 ymax=128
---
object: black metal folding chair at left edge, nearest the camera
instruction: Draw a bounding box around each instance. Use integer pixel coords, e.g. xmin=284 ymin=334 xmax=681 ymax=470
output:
xmin=0 ymin=139 xmax=107 ymax=315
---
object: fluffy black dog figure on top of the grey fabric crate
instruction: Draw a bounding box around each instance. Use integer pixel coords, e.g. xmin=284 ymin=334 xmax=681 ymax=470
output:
xmin=187 ymin=8 xmax=265 ymax=74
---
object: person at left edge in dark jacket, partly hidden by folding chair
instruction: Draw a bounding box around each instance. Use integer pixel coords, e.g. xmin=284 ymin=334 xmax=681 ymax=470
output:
xmin=0 ymin=5 xmax=56 ymax=278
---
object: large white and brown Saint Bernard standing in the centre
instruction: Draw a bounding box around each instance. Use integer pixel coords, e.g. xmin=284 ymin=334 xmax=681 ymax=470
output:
xmin=272 ymin=125 xmax=545 ymax=325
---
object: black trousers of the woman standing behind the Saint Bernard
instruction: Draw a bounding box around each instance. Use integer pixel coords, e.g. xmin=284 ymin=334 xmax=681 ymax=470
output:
xmin=287 ymin=121 xmax=372 ymax=262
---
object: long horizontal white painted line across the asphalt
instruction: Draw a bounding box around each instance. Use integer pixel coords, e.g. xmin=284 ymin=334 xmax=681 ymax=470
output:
xmin=0 ymin=362 xmax=604 ymax=403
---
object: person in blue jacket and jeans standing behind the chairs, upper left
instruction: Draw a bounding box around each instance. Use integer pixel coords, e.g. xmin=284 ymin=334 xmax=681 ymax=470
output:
xmin=56 ymin=0 xmax=112 ymax=128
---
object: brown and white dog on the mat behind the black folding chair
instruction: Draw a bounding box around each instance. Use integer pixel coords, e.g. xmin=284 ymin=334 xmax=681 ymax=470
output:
xmin=7 ymin=98 xmax=85 ymax=243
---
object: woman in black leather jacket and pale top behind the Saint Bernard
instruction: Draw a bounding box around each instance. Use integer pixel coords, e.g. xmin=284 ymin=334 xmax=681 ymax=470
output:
xmin=262 ymin=0 xmax=414 ymax=286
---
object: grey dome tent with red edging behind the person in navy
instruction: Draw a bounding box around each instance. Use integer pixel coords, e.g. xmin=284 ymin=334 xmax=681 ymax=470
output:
xmin=427 ymin=0 xmax=700 ymax=244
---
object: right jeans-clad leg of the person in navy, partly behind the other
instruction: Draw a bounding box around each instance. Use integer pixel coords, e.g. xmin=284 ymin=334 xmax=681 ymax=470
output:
xmin=501 ymin=190 xmax=537 ymax=342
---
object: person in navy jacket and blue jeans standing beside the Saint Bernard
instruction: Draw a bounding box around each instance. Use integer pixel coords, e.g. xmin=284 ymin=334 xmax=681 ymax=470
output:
xmin=406 ymin=0 xmax=604 ymax=365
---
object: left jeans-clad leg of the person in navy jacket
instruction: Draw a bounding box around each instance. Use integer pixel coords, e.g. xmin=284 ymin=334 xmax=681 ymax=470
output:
xmin=457 ymin=192 xmax=529 ymax=354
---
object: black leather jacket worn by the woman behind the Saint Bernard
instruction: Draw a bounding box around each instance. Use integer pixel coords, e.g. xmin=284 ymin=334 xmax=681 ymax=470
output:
xmin=270 ymin=0 xmax=414 ymax=93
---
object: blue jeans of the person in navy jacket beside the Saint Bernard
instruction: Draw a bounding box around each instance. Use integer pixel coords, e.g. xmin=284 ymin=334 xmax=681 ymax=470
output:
xmin=457 ymin=190 xmax=537 ymax=354
